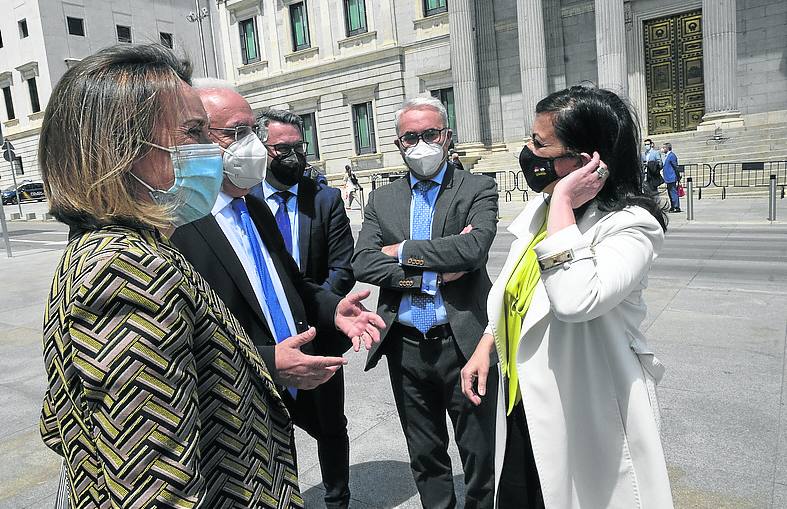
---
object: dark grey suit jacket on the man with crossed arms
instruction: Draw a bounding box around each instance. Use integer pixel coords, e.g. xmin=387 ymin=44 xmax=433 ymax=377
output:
xmin=353 ymin=163 xmax=497 ymax=370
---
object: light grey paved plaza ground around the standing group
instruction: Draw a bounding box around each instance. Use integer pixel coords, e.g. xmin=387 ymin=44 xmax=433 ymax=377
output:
xmin=0 ymin=192 xmax=787 ymax=509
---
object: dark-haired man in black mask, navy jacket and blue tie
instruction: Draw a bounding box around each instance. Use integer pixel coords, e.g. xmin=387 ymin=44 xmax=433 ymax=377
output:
xmin=251 ymin=108 xmax=355 ymax=508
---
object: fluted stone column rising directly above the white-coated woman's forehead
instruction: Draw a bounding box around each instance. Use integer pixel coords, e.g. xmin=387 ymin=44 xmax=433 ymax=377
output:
xmin=516 ymin=0 xmax=549 ymax=138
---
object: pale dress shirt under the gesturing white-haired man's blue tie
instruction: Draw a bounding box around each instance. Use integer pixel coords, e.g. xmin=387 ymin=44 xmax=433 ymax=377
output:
xmin=212 ymin=192 xmax=297 ymax=336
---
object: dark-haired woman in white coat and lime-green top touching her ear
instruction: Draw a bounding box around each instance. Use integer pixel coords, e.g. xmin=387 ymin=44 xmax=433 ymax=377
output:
xmin=461 ymin=86 xmax=672 ymax=509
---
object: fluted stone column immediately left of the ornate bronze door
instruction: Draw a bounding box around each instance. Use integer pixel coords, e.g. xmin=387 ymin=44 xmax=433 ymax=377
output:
xmin=595 ymin=0 xmax=628 ymax=96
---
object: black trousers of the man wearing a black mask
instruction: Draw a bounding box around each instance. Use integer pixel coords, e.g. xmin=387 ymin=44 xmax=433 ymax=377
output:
xmin=285 ymin=368 xmax=350 ymax=509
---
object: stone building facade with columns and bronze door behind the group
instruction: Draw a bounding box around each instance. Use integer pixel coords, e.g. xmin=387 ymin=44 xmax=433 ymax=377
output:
xmin=218 ymin=0 xmax=787 ymax=174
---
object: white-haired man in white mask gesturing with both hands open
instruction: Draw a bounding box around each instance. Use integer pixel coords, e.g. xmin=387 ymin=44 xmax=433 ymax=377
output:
xmin=172 ymin=83 xmax=384 ymax=507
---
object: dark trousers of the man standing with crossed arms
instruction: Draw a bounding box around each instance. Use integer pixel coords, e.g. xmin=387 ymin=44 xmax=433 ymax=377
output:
xmin=385 ymin=324 xmax=497 ymax=509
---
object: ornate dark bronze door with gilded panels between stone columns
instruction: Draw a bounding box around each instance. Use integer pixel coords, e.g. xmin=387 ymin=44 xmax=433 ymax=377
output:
xmin=644 ymin=11 xmax=705 ymax=134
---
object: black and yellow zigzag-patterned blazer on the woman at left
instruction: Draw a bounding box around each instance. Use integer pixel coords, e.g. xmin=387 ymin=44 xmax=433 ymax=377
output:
xmin=41 ymin=225 xmax=303 ymax=509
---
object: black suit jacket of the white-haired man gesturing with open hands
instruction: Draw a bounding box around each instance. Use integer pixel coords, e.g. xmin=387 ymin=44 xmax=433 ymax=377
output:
xmin=172 ymin=195 xmax=341 ymax=378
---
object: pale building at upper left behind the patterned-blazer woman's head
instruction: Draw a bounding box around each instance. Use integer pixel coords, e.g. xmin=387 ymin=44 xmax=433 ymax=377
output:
xmin=0 ymin=0 xmax=223 ymax=189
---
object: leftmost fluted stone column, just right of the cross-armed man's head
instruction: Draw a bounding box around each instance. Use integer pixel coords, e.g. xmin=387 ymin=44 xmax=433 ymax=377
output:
xmin=448 ymin=0 xmax=481 ymax=145
